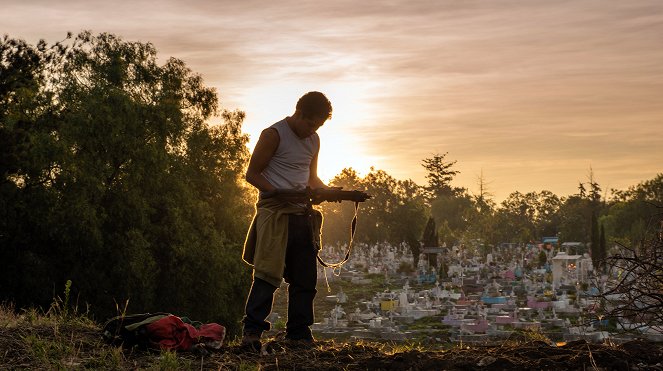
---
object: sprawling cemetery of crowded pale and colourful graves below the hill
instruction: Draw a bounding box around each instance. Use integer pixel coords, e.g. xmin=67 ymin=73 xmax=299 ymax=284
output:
xmin=270 ymin=244 xmax=660 ymax=344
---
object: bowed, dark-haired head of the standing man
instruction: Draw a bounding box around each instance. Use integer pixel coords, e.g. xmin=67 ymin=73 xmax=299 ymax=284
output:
xmin=292 ymin=91 xmax=332 ymax=138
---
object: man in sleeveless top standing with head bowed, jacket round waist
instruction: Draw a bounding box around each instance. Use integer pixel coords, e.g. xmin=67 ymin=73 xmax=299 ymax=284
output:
xmin=242 ymin=92 xmax=332 ymax=350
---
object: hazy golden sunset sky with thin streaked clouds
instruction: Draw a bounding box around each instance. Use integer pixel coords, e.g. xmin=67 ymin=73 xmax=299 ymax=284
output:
xmin=0 ymin=0 xmax=663 ymax=202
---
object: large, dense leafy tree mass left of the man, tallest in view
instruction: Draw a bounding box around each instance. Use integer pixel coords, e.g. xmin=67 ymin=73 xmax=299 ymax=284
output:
xmin=0 ymin=32 xmax=250 ymax=331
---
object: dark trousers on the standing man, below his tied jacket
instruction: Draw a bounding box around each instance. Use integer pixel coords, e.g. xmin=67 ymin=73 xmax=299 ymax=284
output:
xmin=242 ymin=215 xmax=318 ymax=339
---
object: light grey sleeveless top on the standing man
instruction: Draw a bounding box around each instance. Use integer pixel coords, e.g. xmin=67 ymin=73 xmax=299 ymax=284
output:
xmin=262 ymin=119 xmax=320 ymax=189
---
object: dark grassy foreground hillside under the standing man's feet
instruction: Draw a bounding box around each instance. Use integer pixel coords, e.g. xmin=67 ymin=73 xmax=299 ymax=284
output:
xmin=0 ymin=310 xmax=663 ymax=371
